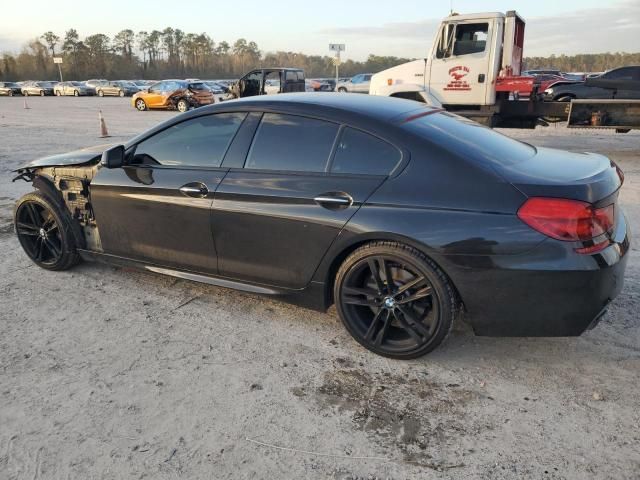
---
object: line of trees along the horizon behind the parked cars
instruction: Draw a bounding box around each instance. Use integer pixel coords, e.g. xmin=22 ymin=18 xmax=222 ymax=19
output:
xmin=0 ymin=27 xmax=640 ymax=81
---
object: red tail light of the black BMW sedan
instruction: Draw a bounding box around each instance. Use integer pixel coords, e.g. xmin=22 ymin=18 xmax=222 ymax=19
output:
xmin=518 ymin=197 xmax=615 ymax=254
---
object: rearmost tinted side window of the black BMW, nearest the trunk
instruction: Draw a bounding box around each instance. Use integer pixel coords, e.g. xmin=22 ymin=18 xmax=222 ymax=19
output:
xmin=331 ymin=127 xmax=401 ymax=175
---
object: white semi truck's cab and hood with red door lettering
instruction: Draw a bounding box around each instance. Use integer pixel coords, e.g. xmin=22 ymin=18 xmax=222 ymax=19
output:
xmin=370 ymin=11 xmax=525 ymax=107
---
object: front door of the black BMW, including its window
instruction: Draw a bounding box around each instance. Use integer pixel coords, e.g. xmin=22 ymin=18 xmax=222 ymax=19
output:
xmin=90 ymin=113 xmax=246 ymax=274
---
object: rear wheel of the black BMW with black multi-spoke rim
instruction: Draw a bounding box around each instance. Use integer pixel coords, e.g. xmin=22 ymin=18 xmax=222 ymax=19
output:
xmin=334 ymin=241 xmax=460 ymax=360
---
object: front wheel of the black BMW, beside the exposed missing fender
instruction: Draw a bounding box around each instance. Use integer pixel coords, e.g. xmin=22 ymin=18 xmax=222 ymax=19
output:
xmin=13 ymin=190 xmax=80 ymax=270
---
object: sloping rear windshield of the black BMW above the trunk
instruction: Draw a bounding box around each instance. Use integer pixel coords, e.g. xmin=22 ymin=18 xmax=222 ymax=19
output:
xmin=403 ymin=112 xmax=536 ymax=166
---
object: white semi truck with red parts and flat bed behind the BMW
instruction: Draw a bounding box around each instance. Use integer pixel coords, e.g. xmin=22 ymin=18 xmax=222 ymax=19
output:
xmin=369 ymin=11 xmax=640 ymax=131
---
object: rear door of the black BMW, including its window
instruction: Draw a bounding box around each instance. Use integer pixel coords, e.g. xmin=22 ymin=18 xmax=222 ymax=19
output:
xmin=212 ymin=113 xmax=396 ymax=289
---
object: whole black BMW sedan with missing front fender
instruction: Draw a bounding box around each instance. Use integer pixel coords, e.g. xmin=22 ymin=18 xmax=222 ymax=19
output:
xmin=15 ymin=93 xmax=629 ymax=359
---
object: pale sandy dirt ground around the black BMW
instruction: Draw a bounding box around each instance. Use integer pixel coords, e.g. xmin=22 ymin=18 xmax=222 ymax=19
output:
xmin=0 ymin=98 xmax=640 ymax=480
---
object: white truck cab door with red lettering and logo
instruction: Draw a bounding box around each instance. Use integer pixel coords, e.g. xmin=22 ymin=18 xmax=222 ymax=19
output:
xmin=429 ymin=18 xmax=495 ymax=105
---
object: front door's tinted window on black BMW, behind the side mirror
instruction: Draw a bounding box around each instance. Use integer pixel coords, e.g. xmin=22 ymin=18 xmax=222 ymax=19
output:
xmin=131 ymin=113 xmax=246 ymax=167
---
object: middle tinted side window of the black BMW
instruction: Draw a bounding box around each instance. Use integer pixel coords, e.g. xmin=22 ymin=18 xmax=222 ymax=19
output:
xmin=245 ymin=113 xmax=338 ymax=172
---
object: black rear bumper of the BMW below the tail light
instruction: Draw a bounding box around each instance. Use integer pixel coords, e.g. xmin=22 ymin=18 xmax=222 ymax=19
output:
xmin=444 ymin=215 xmax=630 ymax=337
